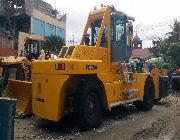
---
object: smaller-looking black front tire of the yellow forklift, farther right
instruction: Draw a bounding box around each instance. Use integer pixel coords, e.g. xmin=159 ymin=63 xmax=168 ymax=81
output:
xmin=134 ymin=77 xmax=155 ymax=111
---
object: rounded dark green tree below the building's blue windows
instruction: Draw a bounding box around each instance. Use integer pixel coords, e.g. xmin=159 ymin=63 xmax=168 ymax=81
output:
xmin=44 ymin=35 xmax=65 ymax=53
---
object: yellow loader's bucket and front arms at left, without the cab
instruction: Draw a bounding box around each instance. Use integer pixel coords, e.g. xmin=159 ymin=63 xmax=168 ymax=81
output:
xmin=0 ymin=60 xmax=32 ymax=115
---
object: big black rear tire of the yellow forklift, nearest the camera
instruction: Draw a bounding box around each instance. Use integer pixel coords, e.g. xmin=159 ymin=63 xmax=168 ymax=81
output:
xmin=74 ymin=80 xmax=102 ymax=130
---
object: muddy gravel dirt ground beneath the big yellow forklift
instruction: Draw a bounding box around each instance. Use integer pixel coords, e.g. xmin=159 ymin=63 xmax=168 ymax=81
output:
xmin=14 ymin=91 xmax=180 ymax=140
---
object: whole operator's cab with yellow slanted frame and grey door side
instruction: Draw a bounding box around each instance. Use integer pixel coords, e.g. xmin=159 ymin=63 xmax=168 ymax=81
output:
xmin=81 ymin=7 xmax=134 ymax=62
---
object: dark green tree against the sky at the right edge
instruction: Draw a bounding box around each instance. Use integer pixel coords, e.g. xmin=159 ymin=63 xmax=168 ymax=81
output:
xmin=149 ymin=20 xmax=180 ymax=67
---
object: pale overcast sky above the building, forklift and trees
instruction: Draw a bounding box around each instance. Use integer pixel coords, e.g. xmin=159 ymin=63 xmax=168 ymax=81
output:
xmin=44 ymin=0 xmax=180 ymax=47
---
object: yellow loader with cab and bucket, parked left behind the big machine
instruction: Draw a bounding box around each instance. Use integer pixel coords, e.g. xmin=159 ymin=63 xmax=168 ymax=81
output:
xmin=0 ymin=37 xmax=43 ymax=115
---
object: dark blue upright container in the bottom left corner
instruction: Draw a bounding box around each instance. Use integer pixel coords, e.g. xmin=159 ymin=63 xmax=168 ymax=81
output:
xmin=0 ymin=98 xmax=16 ymax=140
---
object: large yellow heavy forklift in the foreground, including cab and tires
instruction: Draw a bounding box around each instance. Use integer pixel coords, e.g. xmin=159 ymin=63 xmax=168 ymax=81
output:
xmin=32 ymin=6 xmax=168 ymax=129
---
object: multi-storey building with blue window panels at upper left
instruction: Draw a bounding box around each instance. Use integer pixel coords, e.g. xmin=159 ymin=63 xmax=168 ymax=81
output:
xmin=0 ymin=0 xmax=66 ymax=55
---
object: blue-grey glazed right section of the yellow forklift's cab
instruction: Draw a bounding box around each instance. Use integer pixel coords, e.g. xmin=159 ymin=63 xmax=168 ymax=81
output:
xmin=111 ymin=12 xmax=134 ymax=62
